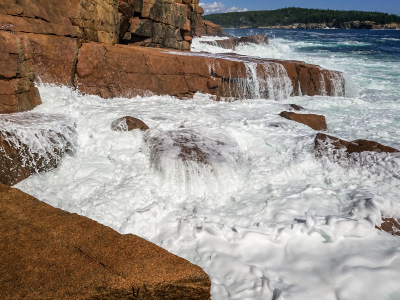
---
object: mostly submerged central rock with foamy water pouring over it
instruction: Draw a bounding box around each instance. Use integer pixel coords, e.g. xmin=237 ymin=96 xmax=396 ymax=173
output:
xmin=145 ymin=128 xmax=240 ymax=197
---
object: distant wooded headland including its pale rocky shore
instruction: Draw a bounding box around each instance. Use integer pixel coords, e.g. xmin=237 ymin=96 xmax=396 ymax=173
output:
xmin=203 ymin=7 xmax=400 ymax=29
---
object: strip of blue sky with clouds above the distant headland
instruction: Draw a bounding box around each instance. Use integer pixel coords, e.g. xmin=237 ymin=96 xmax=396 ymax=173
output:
xmin=200 ymin=0 xmax=400 ymax=15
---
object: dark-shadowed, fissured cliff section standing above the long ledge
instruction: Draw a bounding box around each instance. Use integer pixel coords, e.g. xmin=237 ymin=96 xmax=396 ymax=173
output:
xmin=119 ymin=0 xmax=199 ymax=50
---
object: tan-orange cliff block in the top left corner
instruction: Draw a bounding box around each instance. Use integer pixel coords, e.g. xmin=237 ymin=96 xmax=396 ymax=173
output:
xmin=0 ymin=0 xmax=119 ymax=44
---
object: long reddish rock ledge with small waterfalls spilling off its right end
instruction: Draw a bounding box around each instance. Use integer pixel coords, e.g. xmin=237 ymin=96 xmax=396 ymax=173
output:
xmin=75 ymin=43 xmax=344 ymax=99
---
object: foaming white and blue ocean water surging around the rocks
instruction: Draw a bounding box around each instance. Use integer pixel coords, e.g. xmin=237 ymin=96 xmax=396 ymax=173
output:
xmin=8 ymin=29 xmax=400 ymax=300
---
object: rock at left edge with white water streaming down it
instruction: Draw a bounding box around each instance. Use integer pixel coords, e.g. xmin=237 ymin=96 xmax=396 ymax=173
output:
xmin=0 ymin=113 xmax=77 ymax=185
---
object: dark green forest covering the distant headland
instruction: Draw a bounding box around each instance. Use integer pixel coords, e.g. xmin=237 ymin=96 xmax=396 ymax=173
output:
xmin=203 ymin=7 xmax=400 ymax=28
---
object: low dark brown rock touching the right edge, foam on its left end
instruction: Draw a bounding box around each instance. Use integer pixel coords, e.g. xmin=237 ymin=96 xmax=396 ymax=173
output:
xmin=314 ymin=133 xmax=399 ymax=160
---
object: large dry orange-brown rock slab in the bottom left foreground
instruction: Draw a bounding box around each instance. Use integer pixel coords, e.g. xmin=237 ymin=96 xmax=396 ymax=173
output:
xmin=0 ymin=184 xmax=211 ymax=300
